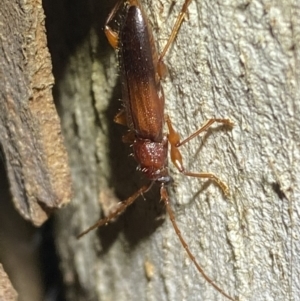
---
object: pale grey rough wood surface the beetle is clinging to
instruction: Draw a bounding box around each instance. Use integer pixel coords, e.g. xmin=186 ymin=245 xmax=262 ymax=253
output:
xmin=45 ymin=0 xmax=300 ymax=301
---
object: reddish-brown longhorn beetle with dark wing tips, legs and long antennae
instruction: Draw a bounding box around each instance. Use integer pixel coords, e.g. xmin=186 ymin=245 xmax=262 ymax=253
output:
xmin=78 ymin=0 xmax=234 ymax=300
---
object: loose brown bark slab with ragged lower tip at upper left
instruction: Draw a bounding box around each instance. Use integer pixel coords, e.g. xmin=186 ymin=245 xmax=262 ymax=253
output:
xmin=0 ymin=0 xmax=71 ymax=225
